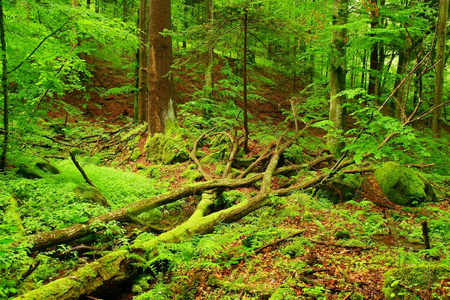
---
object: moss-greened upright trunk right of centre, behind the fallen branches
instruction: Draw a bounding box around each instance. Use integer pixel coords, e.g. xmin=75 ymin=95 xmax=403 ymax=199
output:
xmin=328 ymin=0 xmax=348 ymax=156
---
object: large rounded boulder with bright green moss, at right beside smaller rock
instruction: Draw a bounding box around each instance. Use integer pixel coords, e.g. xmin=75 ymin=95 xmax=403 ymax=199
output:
xmin=374 ymin=162 xmax=436 ymax=206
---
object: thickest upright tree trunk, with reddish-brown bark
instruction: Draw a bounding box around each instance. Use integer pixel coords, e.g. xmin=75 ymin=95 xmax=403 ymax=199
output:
xmin=148 ymin=0 xmax=175 ymax=135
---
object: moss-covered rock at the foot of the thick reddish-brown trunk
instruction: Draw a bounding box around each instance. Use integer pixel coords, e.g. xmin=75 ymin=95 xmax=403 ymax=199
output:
xmin=145 ymin=133 xmax=189 ymax=164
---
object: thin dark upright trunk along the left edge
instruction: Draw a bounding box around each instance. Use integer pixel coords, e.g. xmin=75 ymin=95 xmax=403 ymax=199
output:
xmin=0 ymin=1 xmax=9 ymax=172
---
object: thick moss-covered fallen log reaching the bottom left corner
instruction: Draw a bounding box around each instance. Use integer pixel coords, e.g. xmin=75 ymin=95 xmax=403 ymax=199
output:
xmin=17 ymin=175 xmax=324 ymax=300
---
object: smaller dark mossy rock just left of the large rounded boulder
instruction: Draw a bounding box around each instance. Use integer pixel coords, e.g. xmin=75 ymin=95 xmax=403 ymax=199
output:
xmin=322 ymin=174 xmax=362 ymax=204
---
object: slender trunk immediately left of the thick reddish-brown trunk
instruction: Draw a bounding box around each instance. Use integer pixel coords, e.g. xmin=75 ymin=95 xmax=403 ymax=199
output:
xmin=137 ymin=0 xmax=149 ymax=122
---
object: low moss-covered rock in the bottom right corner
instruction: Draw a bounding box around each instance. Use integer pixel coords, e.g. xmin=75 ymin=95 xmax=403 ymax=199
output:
xmin=383 ymin=265 xmax=450 ymax=300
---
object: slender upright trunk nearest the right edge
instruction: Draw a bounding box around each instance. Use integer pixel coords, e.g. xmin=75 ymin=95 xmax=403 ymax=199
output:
xmin=431 ymin=0 xmax=449 ymax=136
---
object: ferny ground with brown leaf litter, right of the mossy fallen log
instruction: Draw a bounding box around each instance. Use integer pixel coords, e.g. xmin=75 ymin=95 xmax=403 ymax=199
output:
xmin=133 ymin=193 xmax=450 ymax=299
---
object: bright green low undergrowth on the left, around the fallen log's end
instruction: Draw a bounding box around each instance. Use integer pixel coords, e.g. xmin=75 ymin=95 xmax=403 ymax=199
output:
xmin=0 ymin=156 xmax=167 ymax=299
